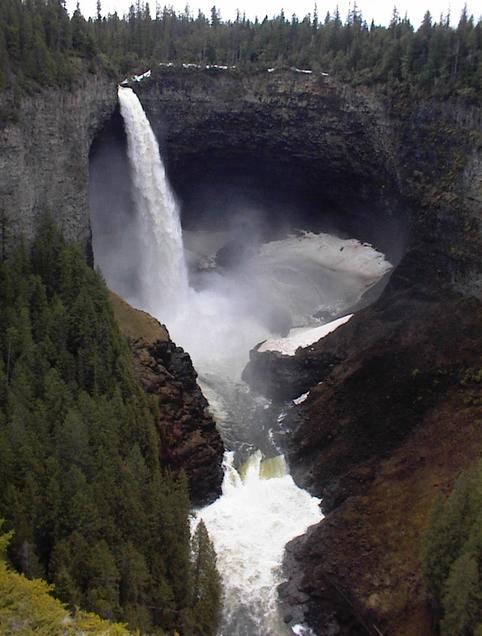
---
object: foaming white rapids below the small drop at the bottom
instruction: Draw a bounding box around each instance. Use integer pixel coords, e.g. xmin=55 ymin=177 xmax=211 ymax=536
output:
xmin=199 ymin=451 xmax=322 ymax=636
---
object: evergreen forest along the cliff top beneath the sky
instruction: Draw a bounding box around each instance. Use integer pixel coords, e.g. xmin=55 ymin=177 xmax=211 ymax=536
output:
xmin=0 ymin=0 xmax=482 ymax=99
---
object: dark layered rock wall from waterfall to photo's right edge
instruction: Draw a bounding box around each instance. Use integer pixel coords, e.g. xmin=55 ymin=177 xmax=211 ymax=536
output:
xmin=134 ymin=67 xmax=482 ymax=278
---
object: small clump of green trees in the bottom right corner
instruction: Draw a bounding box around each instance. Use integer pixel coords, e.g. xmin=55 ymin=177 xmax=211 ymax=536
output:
xmin=422 ymin=460 xmax=482 ymax=636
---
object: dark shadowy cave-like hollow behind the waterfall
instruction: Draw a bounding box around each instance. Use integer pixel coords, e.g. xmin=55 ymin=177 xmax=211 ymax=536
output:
xmin=89 ymin=84 xmax=407 ymax=300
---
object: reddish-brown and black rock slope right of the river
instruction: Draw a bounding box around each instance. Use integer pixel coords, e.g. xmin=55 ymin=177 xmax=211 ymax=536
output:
xmin=280 ymin=288 xmax=482 ymax=636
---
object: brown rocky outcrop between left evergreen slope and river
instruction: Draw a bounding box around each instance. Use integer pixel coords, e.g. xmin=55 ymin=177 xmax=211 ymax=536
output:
xmin=111 ymin=293 xmax=224 ymax=505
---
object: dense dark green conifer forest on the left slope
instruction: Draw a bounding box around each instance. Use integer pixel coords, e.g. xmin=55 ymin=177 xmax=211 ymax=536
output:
xmin=0 ymin=219 xmax=219 ymax=634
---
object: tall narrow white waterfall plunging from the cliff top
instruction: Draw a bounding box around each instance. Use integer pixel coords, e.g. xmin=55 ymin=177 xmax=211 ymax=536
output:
xmin=118 ymin=86 xmax=189 ymax=320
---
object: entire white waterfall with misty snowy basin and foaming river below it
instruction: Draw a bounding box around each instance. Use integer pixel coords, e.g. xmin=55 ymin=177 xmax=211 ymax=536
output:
xmin=100 ymin=87 xmax=391 ymax=636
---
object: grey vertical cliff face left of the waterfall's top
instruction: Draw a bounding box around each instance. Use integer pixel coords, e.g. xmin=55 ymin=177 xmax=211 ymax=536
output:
xmin=0 ymin=74 xmax=117 ymax=249
